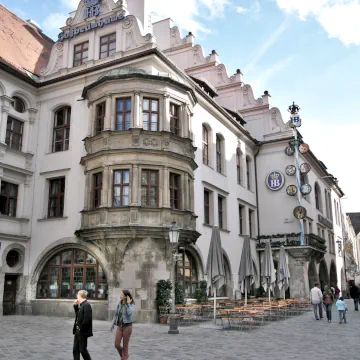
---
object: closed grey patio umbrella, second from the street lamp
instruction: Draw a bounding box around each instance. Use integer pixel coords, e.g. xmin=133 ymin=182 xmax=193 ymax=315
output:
xmin=238 ymin=235 xmax=255 ymax=306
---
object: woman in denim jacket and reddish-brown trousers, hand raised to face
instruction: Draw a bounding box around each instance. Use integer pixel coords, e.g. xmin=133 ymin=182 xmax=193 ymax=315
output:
xmin=110 ymin=290 xmax=135 ymax=360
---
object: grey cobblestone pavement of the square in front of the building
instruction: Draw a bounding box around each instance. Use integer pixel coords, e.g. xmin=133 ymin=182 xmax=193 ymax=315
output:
xmin=0 ymin=303 xmax=360 ymax=360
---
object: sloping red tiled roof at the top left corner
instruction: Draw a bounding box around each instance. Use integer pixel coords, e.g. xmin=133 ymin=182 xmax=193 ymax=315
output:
xmin=0 ymin=5 xmax=54 ymax=75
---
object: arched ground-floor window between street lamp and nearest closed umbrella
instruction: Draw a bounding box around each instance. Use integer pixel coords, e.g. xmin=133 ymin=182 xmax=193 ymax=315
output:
xmin=176 ymin=251 xmax=199 ymax=297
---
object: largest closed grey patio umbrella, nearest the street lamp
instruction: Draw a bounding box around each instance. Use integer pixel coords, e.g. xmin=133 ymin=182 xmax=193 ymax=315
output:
xmin=206 ymin=226 xmax=225 ymax=322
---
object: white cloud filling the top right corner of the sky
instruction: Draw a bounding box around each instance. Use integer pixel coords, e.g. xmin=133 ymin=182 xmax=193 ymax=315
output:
xmin=276 ymin=0 xmax=360 ymax=46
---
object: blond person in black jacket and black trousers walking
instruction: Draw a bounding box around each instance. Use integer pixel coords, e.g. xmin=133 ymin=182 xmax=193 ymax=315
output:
xmin=73 ymin=290 xmax=93 ymax=360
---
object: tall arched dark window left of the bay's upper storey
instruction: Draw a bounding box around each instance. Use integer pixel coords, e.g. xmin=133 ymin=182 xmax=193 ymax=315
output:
xmin=53 ymin=106 xmax=71 ymax=152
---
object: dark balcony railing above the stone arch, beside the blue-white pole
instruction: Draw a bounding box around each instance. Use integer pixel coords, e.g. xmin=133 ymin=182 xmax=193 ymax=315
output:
xmin=256 ymin=234 xmax=326 ymax=252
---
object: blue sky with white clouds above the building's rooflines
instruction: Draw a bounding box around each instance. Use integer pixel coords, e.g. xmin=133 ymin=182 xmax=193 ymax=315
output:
xmin=1 ymin=0 xmax=360 ymax=212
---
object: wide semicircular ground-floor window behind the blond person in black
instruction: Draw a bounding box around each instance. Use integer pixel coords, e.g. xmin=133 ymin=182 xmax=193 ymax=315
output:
xmin=37 ymin=249 xmax=108 ymax=300
